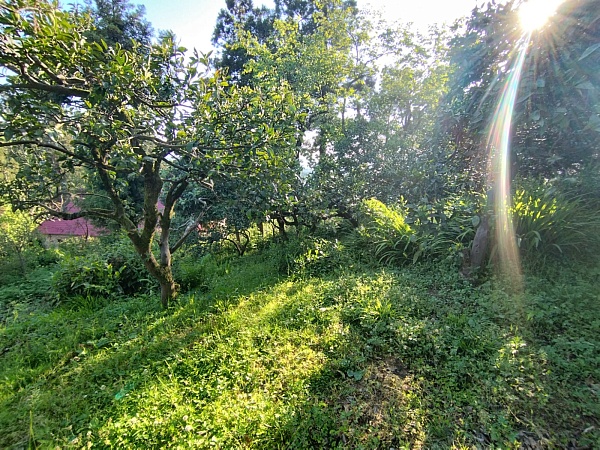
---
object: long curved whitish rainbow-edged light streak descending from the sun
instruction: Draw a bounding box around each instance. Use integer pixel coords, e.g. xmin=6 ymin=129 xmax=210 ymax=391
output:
xmin=487 ymin=34 xmax=531 ymax=290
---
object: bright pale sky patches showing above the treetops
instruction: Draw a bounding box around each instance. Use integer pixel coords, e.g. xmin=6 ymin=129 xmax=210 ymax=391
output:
xmin=138 ymin=0 xmax=481 ymax=53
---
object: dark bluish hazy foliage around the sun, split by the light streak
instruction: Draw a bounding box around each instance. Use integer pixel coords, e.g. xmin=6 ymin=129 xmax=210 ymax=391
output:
xmin=441 ymin=0 xmax=600 ymax=189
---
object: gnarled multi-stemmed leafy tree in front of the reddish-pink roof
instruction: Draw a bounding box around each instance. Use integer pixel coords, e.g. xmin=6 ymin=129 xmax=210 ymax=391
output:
xmin=0 ymin=0 xmax=297 ymax=306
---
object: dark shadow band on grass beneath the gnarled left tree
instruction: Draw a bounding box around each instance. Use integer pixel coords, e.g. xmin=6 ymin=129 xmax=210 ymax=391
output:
xmin=0 ymin=251 xmax=286 ymax=448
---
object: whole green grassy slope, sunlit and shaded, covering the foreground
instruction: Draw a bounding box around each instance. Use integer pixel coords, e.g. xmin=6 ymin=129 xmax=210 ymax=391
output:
xmin=0 ymin=248 xmax=600 ymax=449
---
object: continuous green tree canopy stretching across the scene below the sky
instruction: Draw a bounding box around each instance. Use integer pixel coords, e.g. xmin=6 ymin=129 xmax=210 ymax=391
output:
xmin=0 ymin=0 xmax=600 ymax=305
